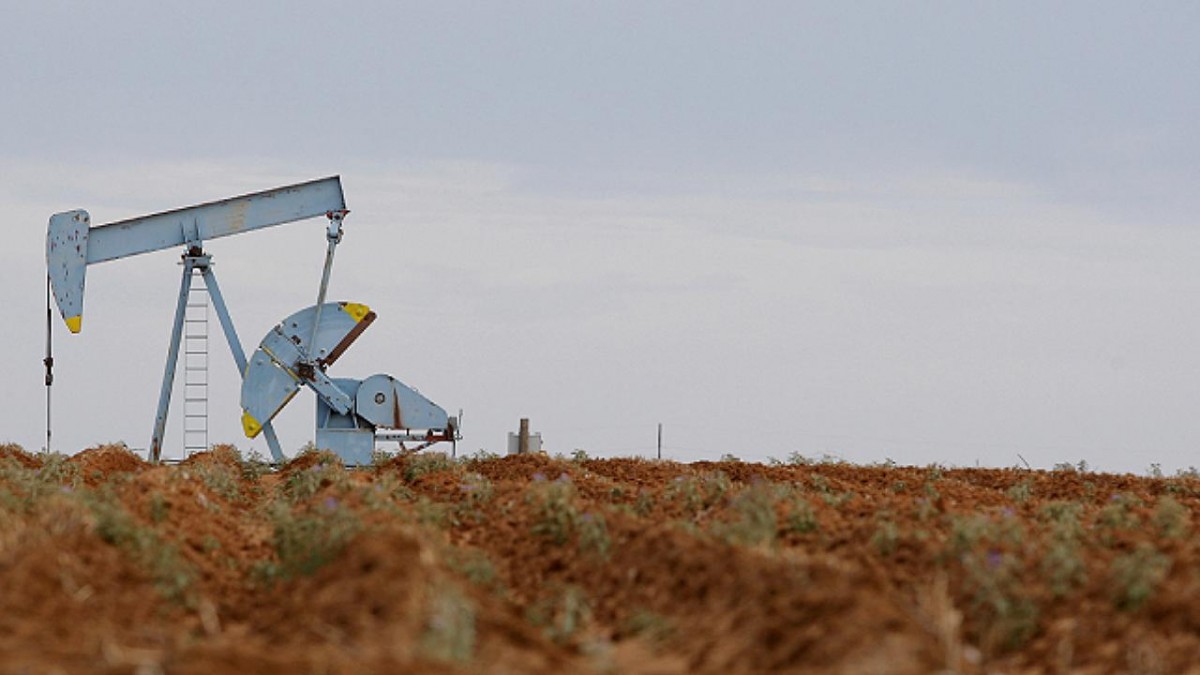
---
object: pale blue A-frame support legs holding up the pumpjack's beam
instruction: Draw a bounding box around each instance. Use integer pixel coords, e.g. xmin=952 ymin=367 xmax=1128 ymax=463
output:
xmin=150 ymin=247 xmax=286 ymax=464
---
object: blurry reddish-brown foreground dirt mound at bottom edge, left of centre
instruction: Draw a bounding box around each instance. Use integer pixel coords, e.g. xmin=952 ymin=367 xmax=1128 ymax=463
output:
xmin=253 ymin=530 xmax=575 ymax=673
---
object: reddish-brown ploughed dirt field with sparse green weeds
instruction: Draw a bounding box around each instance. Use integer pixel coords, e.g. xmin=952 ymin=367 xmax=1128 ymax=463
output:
xmin=0 ymin=446 xmax=1200 ymax=674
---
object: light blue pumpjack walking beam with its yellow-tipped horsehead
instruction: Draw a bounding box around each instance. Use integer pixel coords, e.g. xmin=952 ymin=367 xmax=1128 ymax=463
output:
xmin=46 ymin=175 xmax=346 ymax=333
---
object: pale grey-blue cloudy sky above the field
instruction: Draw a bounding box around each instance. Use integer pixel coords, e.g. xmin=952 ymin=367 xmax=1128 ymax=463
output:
xmin=0 ymin=1 xmax=1200 ymax=472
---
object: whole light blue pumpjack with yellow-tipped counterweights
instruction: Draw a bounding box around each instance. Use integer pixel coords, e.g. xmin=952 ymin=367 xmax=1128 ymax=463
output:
xmin=46 ymin=175 xmax=461 ymax=466
